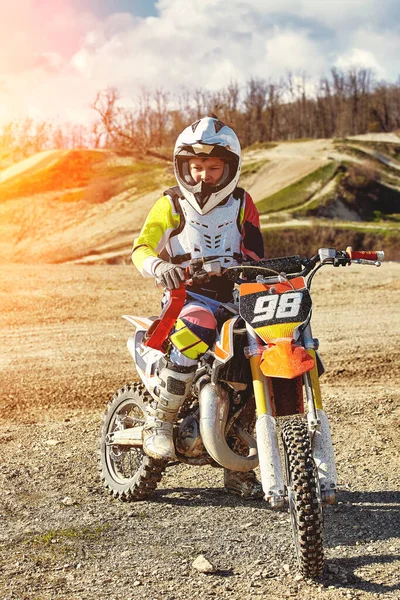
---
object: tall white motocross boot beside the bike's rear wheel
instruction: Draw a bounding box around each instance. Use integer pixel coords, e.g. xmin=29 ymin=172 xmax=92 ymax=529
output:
xmin=143 ymin=358 xmax=197 ymax=460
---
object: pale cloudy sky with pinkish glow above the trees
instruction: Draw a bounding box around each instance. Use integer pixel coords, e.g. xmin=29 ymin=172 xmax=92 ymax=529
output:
xmin=0 ymin=0 xmax=400 ymax=127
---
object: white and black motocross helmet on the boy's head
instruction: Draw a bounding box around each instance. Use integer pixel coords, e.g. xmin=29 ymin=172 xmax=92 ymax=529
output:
xmin=174 ymin=117 xmax=242 ymax=215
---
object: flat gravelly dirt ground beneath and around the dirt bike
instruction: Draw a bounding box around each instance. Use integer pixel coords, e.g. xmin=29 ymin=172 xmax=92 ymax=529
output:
xmin=0 ymin=263 xmax=400 ymax=600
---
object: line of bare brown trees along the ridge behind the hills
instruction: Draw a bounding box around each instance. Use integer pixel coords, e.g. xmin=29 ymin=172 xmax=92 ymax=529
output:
xmin=0 ymin=68 xmax=400 ymax=161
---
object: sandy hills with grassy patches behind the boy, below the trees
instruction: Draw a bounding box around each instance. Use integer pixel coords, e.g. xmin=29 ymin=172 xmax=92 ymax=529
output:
xmin=0 ymin=134 xmax=400 ymax=263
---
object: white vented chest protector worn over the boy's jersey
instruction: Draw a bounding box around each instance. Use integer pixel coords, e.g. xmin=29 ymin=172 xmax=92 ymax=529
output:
xmin=167 ymin=194 xmax=242 ymax=267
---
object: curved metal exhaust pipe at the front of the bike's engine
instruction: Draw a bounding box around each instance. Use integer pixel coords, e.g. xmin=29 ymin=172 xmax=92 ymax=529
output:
xmin=199 ymin=383 xmax=258 ymax=471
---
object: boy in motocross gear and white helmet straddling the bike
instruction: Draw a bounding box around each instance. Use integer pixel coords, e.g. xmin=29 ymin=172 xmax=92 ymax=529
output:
xmin=132 ymin=117 xmax=264 ymax=495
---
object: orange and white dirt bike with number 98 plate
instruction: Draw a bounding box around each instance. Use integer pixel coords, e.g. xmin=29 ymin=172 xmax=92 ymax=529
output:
xmin=100 ymin=248 xmax=384 ymax=578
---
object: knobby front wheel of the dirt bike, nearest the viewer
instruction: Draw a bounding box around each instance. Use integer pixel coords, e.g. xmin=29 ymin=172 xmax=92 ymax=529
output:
xmin=282 ymin=418 xmax=324 ymax=579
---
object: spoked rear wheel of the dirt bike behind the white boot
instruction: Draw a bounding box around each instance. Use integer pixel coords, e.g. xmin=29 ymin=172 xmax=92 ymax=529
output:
xmin=99 ymin=383 xmax=167 ymax=502
